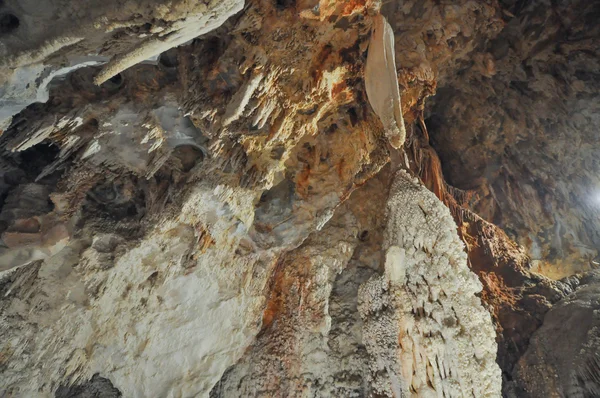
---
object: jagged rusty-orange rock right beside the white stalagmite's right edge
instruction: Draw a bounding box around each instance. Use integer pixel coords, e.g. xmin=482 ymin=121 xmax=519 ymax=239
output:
xmin=460 ymin=214 xmax=573 ymax=388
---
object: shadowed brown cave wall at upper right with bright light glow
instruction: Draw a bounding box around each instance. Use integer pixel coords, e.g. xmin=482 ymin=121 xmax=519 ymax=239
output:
xmin=422 ymin=1 xmax=600 ymax=278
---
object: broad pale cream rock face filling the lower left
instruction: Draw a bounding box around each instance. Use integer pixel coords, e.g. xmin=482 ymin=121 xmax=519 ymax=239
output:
xmin=0 ymin=170 xmax=276 ymax=396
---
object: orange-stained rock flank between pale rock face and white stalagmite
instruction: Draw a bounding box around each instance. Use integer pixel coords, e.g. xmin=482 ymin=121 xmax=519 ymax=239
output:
xmin=212 ymin=170 xmax=389 ymax=397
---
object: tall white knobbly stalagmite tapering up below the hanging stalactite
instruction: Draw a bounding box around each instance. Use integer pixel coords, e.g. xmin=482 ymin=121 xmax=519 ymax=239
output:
xmin=359 ymin=171 xmax=501 ymax=397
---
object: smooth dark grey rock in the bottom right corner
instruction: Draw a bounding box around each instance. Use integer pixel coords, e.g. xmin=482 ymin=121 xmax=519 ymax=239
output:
xmin=509 ymin=271 xmax=600 ymax=397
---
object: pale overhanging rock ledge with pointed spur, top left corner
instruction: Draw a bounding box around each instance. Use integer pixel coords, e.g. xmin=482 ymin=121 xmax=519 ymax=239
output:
xmin=0 ymin=0 xmax=244 ymax=130
